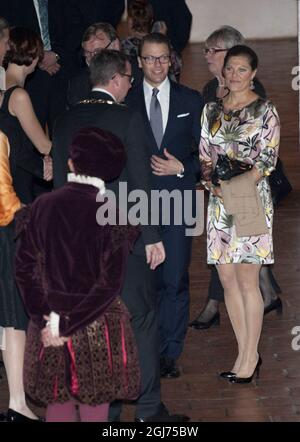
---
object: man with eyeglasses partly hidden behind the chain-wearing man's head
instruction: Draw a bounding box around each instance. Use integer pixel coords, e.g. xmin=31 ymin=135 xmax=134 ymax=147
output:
xmin=68 ymin=23 xmax=120 ymax=107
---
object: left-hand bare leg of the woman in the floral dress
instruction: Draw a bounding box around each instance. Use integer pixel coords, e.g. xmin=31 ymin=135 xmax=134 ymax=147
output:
xmin=217 ymin=264 xmax=247 ymax=373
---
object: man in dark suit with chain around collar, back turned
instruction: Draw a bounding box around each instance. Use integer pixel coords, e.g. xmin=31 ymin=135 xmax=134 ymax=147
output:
xmin=52 ymin=50 xmax=187 ymax=422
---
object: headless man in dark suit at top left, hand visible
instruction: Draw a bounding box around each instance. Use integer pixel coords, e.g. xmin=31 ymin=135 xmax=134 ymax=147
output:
xmin=0 ymin=0 xmax=81 ymax=134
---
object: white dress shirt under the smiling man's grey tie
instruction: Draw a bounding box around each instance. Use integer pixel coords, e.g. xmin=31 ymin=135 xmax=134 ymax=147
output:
xmin=143 ymin=77 xmax=170 ymax=133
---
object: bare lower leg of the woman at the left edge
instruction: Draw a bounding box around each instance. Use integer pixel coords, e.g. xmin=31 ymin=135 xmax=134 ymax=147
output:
xmin=2 ymin=328 xmax=37 ymax=419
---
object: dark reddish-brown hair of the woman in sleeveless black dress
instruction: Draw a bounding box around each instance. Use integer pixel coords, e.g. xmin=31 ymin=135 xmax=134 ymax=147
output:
xmin=3 ymin=27 xmax=44 ymax=66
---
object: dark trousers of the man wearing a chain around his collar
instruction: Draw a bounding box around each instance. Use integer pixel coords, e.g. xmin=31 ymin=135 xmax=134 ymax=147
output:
xmin=109 ymin=255 xmax=161 ymax=422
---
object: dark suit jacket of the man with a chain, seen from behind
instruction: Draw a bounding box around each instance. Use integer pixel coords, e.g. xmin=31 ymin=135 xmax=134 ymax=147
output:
xmin=52 ymin=92 xmax=160 ymax=255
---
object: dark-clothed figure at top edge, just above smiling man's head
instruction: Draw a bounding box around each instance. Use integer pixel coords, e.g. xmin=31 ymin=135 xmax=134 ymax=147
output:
xmin=150 ymin=0 xmax=192 ymax=54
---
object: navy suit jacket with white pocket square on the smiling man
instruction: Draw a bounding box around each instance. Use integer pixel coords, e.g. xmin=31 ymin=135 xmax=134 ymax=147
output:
xmin=126 ymin=81 xmax=203 ymax=190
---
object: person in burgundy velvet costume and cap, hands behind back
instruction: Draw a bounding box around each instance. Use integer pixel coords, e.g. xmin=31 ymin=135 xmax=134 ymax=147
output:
xmin=15 ymin=127 xmax=140 ymax=422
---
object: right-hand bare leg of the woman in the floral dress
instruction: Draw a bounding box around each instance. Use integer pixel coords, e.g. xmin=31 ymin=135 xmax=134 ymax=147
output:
xmin=237 ymin=264 xmax=264 ymax=378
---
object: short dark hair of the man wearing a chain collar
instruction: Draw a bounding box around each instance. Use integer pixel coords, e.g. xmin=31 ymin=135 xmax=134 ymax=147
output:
xmin=89 ymin=49 xmax=129 ymax=87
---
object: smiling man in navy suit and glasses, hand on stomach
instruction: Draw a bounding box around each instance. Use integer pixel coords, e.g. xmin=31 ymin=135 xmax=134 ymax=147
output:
xmin=127 ymin=33 xmax=202 ymax=378
